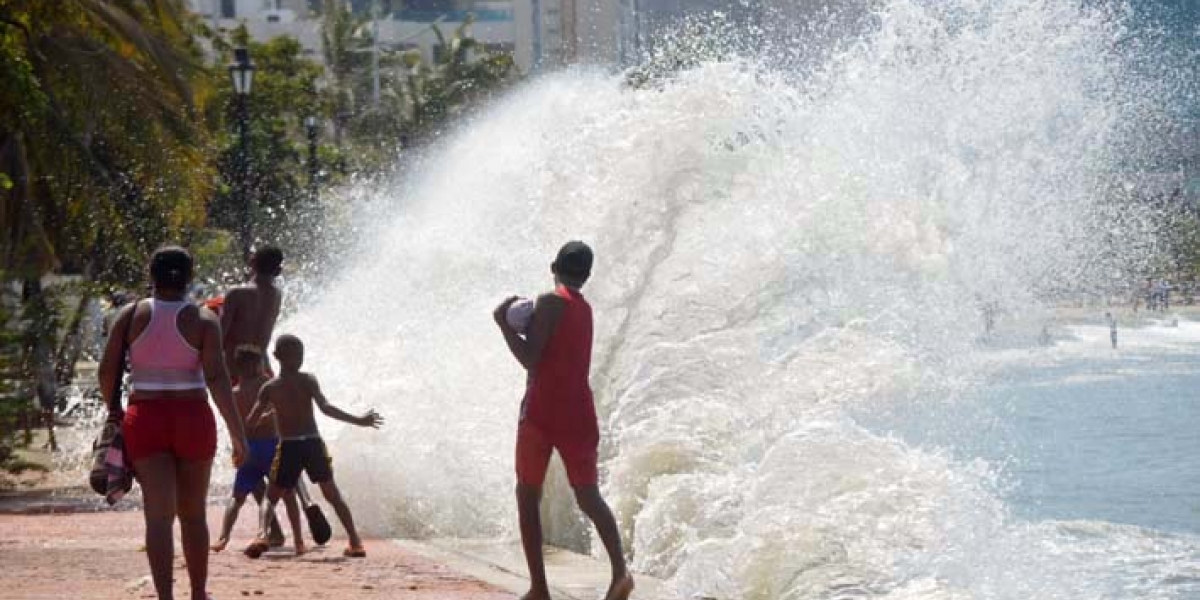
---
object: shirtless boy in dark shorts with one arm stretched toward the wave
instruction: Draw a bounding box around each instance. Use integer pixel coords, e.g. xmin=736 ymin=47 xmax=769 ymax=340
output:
xmin=246 ymin=335 xmax=383 ymax=558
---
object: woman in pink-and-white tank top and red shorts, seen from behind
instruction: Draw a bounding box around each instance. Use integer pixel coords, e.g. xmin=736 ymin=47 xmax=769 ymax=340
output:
xmin=100 ymin=246 xmax=246 ymax=600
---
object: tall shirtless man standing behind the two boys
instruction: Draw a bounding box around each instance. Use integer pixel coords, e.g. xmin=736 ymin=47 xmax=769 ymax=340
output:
xmin=221 ymin=245 xmax=283 ymax=372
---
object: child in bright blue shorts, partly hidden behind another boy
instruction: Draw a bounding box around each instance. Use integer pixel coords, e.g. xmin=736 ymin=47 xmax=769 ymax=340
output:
xmin=211 ymin=344 xmax=307 ymax=556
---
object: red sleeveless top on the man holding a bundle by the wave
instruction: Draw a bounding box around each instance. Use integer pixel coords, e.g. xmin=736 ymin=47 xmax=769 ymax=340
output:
xmin=524 ymin=286 xmax=599 ymax=437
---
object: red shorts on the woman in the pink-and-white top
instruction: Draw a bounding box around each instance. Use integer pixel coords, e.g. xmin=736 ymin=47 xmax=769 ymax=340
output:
xmin=121 ymin=398 xmax=217 ymax=463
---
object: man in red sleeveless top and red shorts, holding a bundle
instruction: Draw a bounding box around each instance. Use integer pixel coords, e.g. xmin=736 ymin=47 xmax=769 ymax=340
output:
xmin=493 ymin=241 xmax=634 ymax=600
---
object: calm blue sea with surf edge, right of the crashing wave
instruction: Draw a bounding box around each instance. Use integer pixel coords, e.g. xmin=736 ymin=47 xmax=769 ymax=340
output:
xmin=864 ymin=311 xmax=1200 ymax=536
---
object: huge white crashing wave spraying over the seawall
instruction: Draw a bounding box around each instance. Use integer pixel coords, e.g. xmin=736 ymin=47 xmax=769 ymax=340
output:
xmin=283 ymin=0 xmax=1198 ymax=599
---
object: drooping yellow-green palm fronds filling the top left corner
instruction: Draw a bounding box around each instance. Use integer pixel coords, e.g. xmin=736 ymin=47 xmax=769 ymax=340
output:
xmin=0 ymin=0 xmax=212 ymax=284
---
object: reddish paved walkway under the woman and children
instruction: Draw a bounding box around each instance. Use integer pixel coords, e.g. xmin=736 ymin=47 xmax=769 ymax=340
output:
xmin=0 ymin=510 xmax=515 ymax=600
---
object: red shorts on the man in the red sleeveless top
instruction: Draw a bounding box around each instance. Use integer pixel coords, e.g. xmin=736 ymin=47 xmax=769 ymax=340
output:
xmin=516 ymin=421 xmax=600 ymax=487
